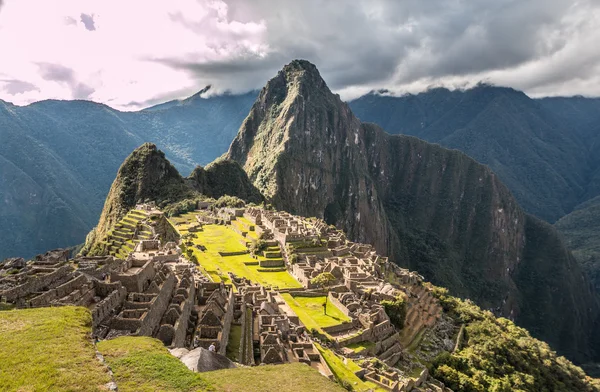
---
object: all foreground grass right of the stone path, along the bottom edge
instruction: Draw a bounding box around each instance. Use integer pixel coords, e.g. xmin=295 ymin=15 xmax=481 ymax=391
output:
xmin=98 ymin=337 xmax=343 ymax=392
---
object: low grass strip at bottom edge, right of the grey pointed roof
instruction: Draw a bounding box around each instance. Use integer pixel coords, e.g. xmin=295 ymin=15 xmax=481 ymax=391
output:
xmin=202 ymin=363 xmax=344 ymax=392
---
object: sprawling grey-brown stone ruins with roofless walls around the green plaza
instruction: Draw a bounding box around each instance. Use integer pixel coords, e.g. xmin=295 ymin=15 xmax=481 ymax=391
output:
xmin=0 ymin=204 xmax=452 ymax=391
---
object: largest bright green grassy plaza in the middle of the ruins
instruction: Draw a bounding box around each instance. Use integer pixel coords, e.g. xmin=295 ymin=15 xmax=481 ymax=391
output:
xmin=171 ymin=212 xmax=302 ymax=288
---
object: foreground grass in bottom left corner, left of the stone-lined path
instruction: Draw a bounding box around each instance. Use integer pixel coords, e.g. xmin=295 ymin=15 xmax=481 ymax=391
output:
xmin=0 ymin=306 xmax=111 ymax=391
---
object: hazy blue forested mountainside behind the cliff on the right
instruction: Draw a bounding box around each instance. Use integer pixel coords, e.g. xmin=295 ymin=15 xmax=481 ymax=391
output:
xmin=349 ymin=84 xmax=600 ymax=223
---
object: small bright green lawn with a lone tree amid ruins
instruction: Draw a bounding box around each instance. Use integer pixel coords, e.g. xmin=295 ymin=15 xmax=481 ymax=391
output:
xmin=281 ymin=293 xmax=351 ymax=332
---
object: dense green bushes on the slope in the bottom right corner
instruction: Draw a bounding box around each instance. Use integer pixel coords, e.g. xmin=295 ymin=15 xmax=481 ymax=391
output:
xmin=431 ymin=288 xmax=600 ymax=392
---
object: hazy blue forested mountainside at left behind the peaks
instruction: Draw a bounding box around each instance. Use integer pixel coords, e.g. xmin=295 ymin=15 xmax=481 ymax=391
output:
xmin=0 ymin=89 xmax=256 ymax=259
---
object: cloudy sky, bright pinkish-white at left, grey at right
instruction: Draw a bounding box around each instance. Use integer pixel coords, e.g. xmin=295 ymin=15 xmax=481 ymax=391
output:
xmin=0 ymin=0 xmax=600 ymax=110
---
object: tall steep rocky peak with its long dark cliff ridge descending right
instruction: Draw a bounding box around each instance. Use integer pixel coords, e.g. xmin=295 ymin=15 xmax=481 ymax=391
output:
xmin=226 ymin=60 xmax=598 ymax=361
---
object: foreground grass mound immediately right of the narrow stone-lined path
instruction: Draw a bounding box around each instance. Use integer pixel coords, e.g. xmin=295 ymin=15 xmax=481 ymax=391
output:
xmin=98 ymin=336 xmax=214 ymax=392
